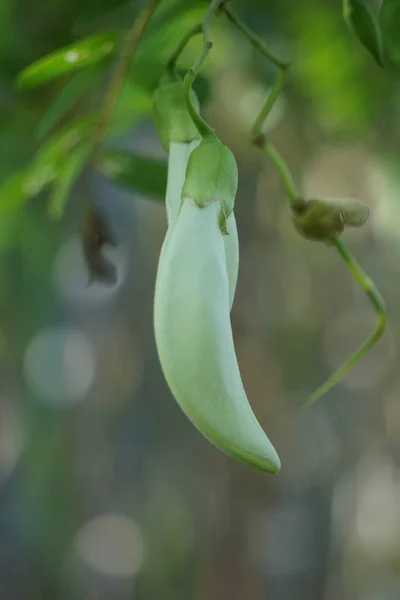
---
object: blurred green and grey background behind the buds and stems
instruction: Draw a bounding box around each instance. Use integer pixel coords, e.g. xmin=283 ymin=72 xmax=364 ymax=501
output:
xmin=0 ymin=0 xmax=400 ymax=600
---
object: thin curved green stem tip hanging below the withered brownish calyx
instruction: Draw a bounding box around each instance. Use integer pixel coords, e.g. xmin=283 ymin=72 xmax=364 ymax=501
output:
xmin=302 ymin=237 xmax=386 ymax=406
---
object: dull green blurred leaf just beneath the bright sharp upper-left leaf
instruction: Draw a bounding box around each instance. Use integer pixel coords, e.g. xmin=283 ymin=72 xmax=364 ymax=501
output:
xmin=37 ymin=69 xmax=98 ymax=140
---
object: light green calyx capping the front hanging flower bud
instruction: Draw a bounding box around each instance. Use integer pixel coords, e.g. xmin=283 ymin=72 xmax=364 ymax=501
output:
xmin=182 ymin=134 xmax=238 ymax=235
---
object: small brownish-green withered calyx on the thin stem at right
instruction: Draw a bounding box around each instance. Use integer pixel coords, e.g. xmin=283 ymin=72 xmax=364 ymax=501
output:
xmin=292 ymin=200 xmax=369 ymax=242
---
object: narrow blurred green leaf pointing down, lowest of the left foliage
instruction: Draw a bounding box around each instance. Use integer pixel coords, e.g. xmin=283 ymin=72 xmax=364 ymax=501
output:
xmin=48 ymin=144 xmax=92 ymax=219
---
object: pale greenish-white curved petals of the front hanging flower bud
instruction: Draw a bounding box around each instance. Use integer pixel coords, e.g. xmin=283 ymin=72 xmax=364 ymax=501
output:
xmin=154 ymin=191 xmax=280 ymax=473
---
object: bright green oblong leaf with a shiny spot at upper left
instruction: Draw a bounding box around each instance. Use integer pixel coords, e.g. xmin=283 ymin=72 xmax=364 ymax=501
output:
xmin=17 ymin=33 xmax=118 ymax=88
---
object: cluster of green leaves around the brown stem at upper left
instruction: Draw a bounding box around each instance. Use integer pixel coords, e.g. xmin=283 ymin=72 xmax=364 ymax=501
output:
xmin=5 ymin=0 xmax=228 ymax=218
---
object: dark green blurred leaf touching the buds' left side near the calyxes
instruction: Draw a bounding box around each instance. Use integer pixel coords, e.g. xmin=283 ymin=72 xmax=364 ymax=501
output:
xmin=98 ymin=150 xmax=167 ymax=200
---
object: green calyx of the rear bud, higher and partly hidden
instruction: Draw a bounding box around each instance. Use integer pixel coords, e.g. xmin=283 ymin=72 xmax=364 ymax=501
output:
xmin=153 ymin=80 xmax=200 ymax=150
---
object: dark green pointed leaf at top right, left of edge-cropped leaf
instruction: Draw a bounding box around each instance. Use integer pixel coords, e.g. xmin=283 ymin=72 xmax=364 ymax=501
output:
xmin=343 ymin=0 xmax=383 ymax=66
